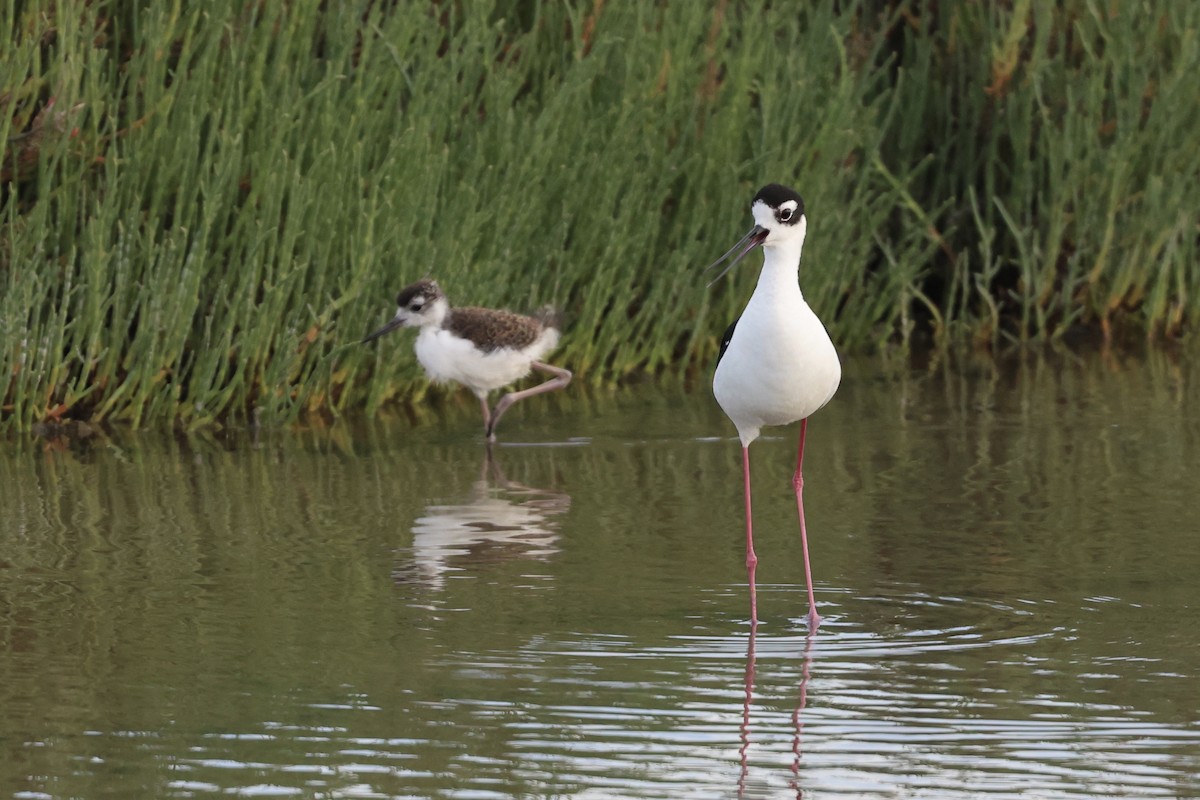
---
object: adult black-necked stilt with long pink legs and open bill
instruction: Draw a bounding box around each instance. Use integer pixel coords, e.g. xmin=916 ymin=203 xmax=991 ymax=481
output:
xmin=709 ymin=184 xmax=841 ymax=630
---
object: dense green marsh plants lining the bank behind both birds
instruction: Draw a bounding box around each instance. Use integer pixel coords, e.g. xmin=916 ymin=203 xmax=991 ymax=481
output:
xmin=0 ymin=0 xmax=1200 ymax=428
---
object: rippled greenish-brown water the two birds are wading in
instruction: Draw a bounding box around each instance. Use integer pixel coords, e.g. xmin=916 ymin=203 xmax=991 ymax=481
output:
xmin=0 ymin=354 xmax=1200 ymax=800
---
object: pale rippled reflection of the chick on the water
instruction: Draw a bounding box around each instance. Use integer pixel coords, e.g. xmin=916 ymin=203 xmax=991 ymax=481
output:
xmin=394 ymin=449 xmax=571 ymax=590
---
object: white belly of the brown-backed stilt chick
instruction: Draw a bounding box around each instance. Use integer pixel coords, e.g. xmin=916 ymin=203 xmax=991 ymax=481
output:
xmin=416 ymin=329 xmax=557 ymax=395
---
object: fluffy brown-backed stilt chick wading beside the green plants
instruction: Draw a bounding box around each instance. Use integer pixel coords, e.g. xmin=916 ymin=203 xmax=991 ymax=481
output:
xmin=362 ymin=279 xmax=571 ymax=443
